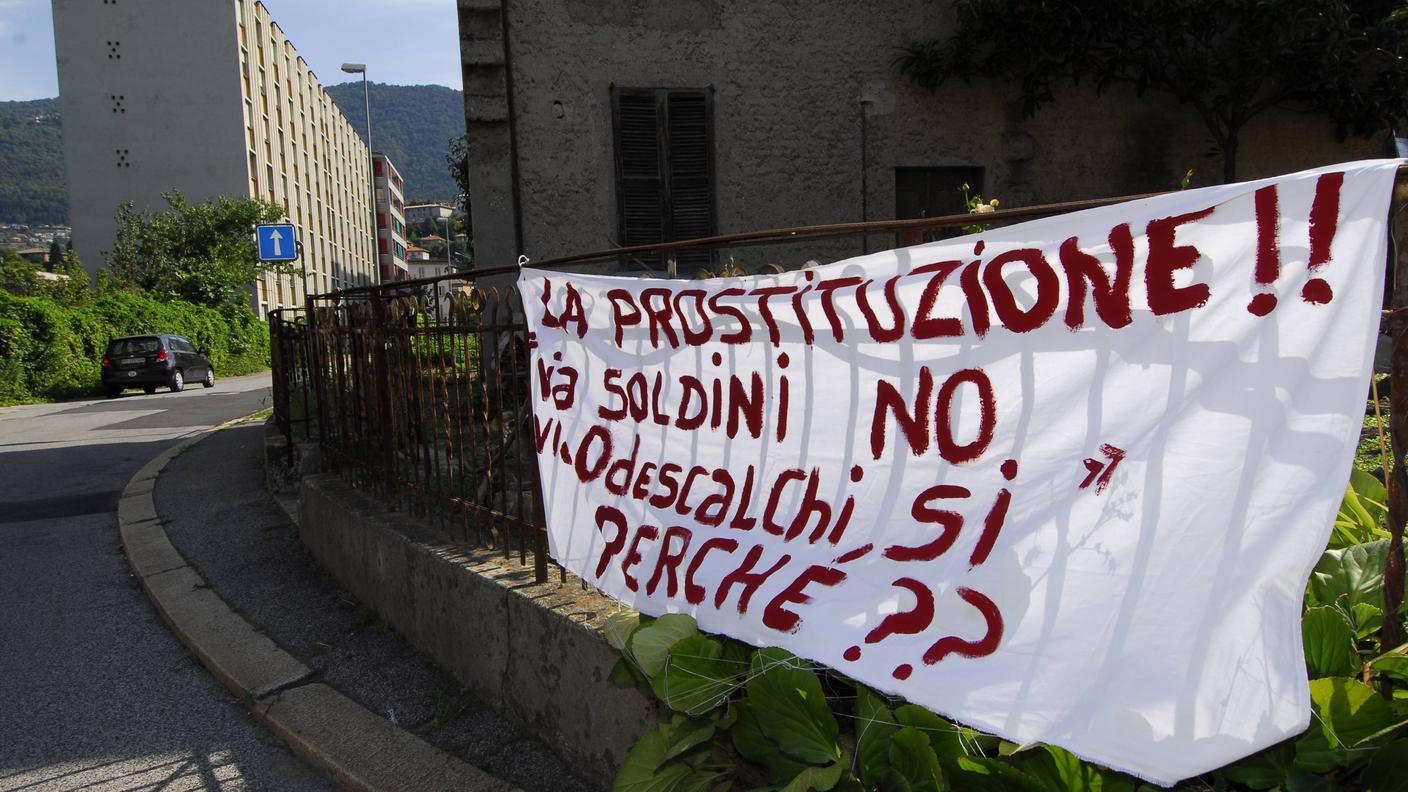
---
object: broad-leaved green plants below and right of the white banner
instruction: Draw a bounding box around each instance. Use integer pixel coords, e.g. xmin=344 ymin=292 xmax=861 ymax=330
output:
xmin=604 ymin=472 xmax=1408 ymax=792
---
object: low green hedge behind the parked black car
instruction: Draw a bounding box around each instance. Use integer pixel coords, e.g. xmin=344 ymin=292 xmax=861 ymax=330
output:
xmin=0 ymin=290 xmax=269 ymax=404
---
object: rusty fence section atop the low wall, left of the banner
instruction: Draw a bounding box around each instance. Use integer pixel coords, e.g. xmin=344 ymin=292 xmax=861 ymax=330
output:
xmin=297 ymin=278 xmax=548 ymax=572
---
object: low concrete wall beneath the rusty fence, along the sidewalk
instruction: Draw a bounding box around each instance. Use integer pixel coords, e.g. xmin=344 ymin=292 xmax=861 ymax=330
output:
xmin=298 ymin=475 xmax=658 ymax=785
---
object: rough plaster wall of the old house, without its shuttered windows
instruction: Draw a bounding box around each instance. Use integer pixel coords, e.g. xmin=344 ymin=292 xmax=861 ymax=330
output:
xmin=460 ymin=0 xmax=1384 ymax=266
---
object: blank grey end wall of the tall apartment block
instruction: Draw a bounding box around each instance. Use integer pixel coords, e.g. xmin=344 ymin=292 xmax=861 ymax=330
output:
xmin=54 ymin=0 xmax=249 ymax=280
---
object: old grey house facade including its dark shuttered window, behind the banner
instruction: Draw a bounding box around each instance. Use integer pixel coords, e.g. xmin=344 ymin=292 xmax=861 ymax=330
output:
xmin=459 ymin=0 xmax=1387 ymax=273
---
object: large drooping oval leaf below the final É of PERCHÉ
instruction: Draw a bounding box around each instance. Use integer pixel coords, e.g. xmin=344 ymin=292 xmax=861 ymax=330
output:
xmin=748 ymin=648 xmax=841 ymax=765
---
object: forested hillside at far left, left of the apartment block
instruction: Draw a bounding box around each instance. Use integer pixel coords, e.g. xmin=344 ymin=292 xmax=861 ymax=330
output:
xmin=0 ymin=99 xmax=67 ymax=225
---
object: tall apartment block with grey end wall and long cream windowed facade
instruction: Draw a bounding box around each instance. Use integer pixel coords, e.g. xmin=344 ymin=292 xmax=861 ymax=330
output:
xmin=54 ymin=0 xmax=376 ymax=316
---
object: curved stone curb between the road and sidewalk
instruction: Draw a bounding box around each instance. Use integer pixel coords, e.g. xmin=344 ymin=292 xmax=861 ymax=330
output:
xmin=117 ymin=416 xmax=517 ymax=792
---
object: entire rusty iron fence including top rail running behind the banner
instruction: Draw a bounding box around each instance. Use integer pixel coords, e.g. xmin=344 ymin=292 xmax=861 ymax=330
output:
xmin=270 ymin=181 xmax=1408 ymax=582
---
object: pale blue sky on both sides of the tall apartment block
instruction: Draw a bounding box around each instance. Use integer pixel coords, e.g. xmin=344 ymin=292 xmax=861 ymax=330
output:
xmin=0 ymin=0 xmax=460 ymax=101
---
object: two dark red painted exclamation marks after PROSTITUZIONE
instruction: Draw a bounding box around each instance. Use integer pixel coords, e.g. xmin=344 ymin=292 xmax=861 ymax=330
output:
xmin=1246 ymin=172 xmax=1345 ymax=316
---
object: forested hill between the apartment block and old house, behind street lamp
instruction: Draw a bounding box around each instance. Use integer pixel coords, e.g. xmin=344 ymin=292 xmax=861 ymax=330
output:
xmin=327 ymin=80 xmax=465 ymax=203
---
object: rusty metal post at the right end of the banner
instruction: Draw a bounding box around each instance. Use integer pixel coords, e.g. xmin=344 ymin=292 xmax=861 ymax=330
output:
xmin=1378 ymin=171 xmax=1408 ymax=690
